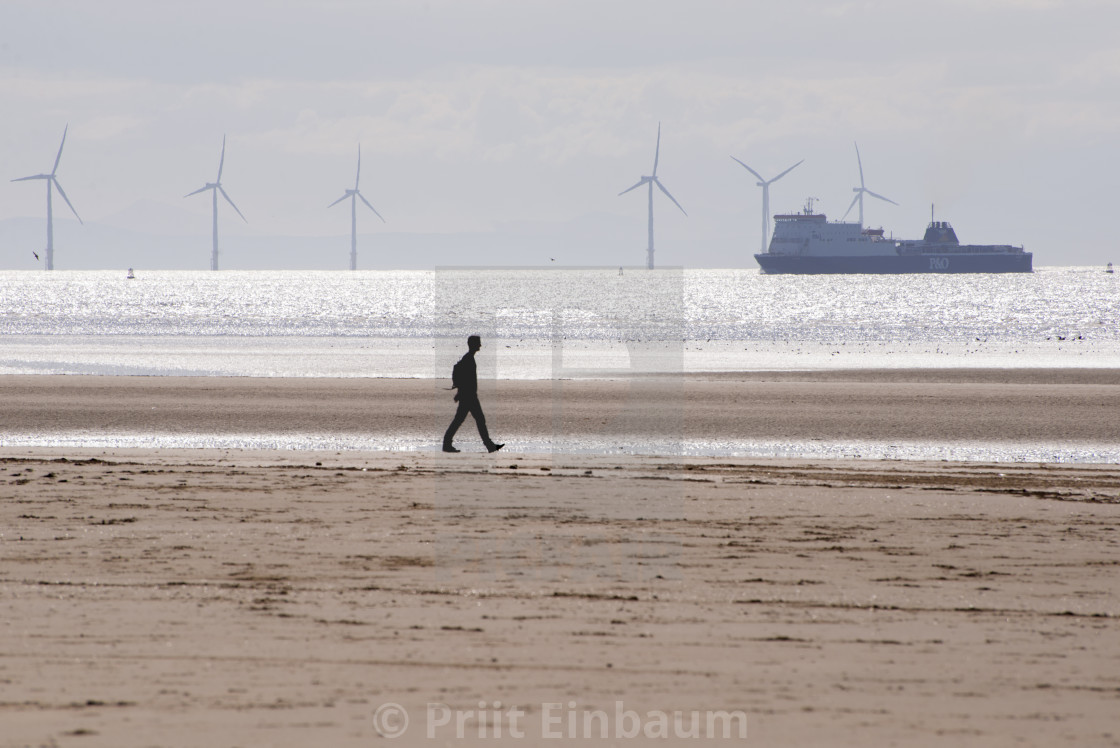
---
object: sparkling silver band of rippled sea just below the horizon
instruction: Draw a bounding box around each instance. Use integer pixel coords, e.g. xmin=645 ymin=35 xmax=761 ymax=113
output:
xmin=0 ymin=268 xmax=1120 ymax=365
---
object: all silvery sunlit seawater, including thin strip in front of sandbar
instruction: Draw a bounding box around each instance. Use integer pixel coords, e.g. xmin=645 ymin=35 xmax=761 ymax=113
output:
xmin=0 ymin=267 xmax=1120 ymax=461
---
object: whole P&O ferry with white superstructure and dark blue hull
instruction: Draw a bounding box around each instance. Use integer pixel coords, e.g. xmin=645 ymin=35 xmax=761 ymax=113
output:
xmin=755 ymin=200 xmax=1034 ymax=274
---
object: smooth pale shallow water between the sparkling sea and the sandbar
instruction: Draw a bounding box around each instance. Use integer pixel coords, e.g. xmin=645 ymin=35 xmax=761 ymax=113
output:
xmin=0 ymin=336 xmax=1120 ymax=380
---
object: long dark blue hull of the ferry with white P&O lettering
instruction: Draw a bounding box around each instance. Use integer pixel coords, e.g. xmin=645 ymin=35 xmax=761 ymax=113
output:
xmin=755 ymin=252 xmax=1034 ymax=275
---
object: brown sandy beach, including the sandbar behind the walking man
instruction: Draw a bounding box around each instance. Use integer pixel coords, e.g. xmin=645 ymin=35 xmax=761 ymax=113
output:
xmin=0 ymin=370 xmax=1120 ymax=746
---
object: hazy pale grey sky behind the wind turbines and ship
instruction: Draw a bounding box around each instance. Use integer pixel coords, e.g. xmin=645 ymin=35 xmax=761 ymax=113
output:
xmin=0 ymin=0 xmax=1120 ymax=269
